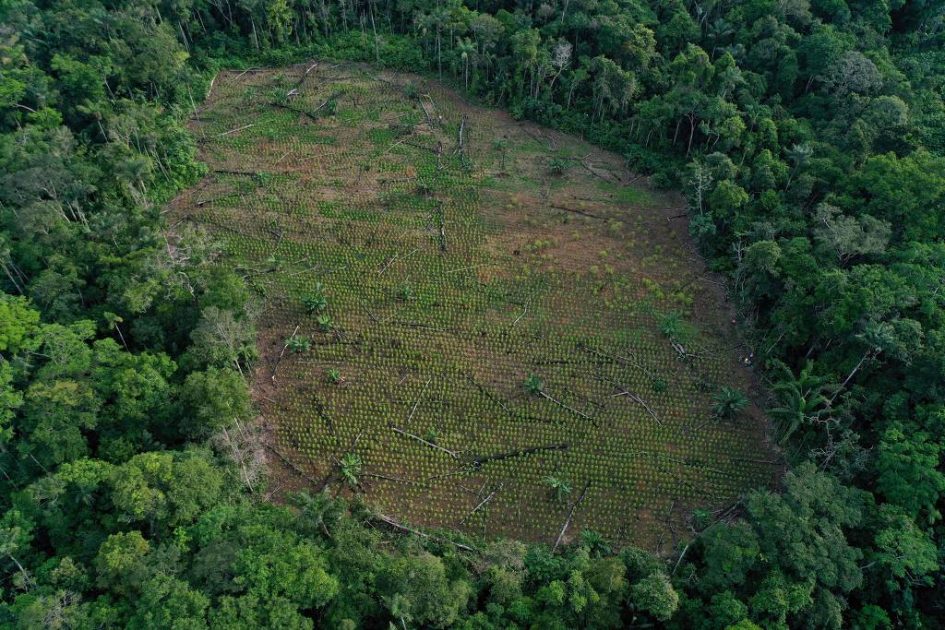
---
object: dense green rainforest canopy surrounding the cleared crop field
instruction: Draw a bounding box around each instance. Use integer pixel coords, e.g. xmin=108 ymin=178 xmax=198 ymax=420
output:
xmin=0 ymin=0 xmax=945 ymax=630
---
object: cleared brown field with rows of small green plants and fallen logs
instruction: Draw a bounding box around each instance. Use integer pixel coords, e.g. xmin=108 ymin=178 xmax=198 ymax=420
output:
xmin=171 ymin=63 xmax=778 ymax=549
